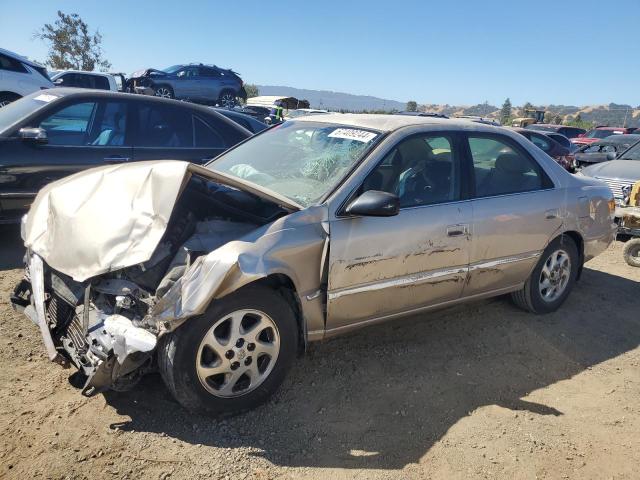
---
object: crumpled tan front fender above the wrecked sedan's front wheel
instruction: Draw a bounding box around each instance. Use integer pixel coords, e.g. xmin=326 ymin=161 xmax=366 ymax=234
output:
xmin=149 ymin=207 xmax=328 ymax=339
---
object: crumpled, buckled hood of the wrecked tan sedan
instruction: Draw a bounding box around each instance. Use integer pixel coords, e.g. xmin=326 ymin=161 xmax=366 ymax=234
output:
xmin=25 ymin=160 xmax=191 ymax=282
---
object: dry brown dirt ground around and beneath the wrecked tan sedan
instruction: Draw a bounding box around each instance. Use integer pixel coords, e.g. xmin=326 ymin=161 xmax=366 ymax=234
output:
xmin=0 ymin=228 xmax=640 ymax=480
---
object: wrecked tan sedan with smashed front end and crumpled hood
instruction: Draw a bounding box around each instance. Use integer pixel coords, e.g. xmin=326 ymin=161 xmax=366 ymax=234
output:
xmin=12 ymin=114 xmax=615 ymax=415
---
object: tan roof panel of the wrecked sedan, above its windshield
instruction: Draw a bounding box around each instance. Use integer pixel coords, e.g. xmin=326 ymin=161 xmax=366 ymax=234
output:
xmin=289 ymin=113 xmax=502 ymax=132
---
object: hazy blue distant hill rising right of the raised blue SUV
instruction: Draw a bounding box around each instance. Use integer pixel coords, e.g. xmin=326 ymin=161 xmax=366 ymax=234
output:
xmin=258 ymin=85 xmax=406 ymax=112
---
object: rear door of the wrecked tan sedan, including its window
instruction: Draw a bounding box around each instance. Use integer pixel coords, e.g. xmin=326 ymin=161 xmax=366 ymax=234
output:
xmin=463 ymin=133 xmax=564 ymax=296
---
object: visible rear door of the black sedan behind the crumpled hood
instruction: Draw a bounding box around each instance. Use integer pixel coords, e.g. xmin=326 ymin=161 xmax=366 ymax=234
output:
xmin=133 ymin=102 xmax=244 ymax=164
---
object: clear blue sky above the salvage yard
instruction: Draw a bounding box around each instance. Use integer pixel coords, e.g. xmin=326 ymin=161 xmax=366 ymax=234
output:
xmin=0 ymin=0 xmax=640 ymax=106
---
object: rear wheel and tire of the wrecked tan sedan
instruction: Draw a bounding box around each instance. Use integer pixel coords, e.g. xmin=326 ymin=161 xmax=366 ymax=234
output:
xmin=511 ymin=235 xmax=580 ymax=314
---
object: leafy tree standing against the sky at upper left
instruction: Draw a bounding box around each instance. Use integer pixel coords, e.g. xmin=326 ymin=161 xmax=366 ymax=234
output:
xmin=35 ymin=10 xmax=111 ymax=71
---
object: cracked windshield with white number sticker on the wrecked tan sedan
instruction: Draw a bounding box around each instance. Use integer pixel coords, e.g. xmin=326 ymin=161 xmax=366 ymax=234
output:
xmin=207 ymin=121 xmax=380 ymax=207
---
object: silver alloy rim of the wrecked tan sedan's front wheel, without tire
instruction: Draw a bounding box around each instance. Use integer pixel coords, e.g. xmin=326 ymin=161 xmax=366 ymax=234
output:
xmin=196 ymin=310 xmax=280 ymax=398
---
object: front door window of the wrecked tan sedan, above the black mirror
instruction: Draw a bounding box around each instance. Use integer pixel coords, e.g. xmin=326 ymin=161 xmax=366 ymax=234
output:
xmin=361 ymin=135 xmax=460 ymax=208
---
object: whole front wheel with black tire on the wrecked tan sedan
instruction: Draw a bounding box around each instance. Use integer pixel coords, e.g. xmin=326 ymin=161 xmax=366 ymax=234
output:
xmin=158 ymin=286 xmax=298 ymax=417
